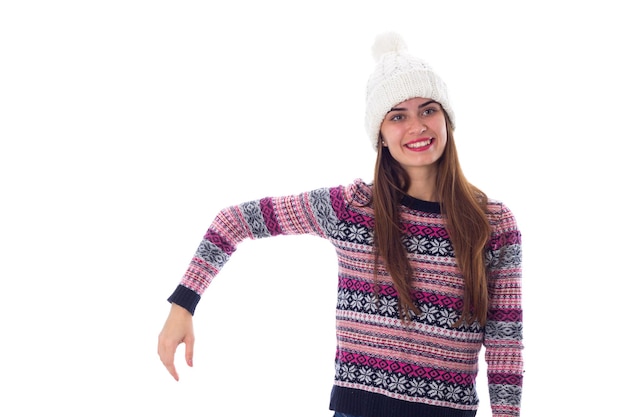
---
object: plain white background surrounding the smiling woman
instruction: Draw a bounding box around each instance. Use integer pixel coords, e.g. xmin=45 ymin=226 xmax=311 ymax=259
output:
xmin=0 ymin=0 xmax=626 ymax=417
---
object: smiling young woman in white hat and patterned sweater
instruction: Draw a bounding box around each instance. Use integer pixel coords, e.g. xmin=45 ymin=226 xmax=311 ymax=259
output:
xmin=158 ymin=33 xmax=523 ymax=417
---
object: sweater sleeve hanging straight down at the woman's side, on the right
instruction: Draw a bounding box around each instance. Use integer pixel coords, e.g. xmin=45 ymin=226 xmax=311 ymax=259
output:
xmin=484 ymin=200 xmax=524 ymax=417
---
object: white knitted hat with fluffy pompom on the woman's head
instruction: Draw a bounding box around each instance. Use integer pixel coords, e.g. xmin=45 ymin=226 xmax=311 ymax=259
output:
xmin=365 ymin=32 xmax=454 ymax=149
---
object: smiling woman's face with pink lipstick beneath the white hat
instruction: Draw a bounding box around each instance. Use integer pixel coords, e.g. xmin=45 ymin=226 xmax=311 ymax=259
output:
xmin=380 ymin=97 xmax=448 ymax=175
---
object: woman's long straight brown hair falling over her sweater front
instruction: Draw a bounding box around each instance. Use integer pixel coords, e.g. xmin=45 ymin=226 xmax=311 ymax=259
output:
xmin=372 ymin=111 xmax=491 ymax=325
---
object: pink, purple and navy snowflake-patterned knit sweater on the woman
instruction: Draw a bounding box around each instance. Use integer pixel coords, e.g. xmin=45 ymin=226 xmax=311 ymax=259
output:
xmin=168 ymin=180 xmax=523 ymax=417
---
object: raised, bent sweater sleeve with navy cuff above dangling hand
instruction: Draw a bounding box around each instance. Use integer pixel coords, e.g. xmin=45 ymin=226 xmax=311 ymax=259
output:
xmin=163 ymin=185 xmax=332 ymax=314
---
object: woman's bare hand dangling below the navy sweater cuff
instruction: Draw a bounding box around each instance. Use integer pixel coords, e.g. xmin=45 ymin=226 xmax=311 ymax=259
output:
xmin=158 ymin=303 xmax=194 ymax=381
